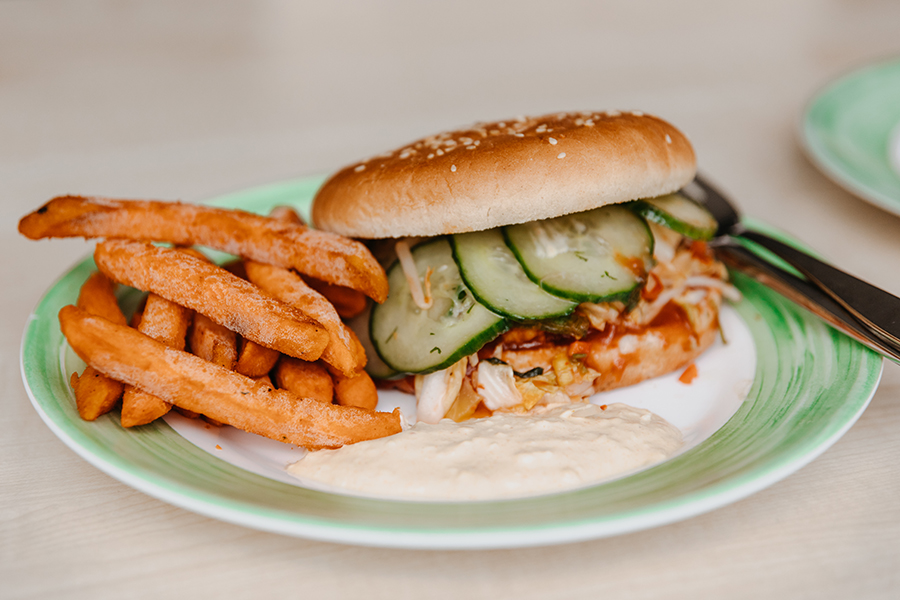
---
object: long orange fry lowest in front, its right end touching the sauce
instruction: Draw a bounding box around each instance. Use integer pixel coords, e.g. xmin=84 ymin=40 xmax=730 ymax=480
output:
xmin=59 ymin=306 xmax=401 ymax=448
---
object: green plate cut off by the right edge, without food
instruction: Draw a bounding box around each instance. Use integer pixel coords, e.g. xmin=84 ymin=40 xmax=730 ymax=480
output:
xmin=801 ymin=59 xmax=900 ymax=215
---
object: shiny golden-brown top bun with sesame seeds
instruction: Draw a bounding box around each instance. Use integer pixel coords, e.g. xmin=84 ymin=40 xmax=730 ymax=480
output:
xmin=312 ymin=111 xmax=696 ymax=238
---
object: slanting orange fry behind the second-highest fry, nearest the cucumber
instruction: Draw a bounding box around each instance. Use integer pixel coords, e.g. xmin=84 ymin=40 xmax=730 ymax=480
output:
xmin=244 ymin=260 xmax=366 ymax=376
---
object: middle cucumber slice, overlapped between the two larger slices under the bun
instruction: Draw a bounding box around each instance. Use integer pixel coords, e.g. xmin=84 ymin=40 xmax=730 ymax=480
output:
xmin=450 ymin=229 xmax=578 ymax=321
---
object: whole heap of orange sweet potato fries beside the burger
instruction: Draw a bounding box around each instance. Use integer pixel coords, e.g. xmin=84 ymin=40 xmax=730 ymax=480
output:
xmin=19 ymin=196 xmax=401 ymax=448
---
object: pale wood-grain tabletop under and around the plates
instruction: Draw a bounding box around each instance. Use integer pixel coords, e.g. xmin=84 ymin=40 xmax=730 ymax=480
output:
xmin=0 ymin=0 xmax=900 ymax=599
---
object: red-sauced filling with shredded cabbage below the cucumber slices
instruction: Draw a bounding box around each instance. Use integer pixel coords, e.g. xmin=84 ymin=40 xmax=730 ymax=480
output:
xmin=395 ymin=236 xmax=737 ymax=421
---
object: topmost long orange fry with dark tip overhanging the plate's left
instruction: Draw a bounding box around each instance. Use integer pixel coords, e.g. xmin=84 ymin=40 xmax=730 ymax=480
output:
xmin=19 ymin=196 xmax=388 ymax=302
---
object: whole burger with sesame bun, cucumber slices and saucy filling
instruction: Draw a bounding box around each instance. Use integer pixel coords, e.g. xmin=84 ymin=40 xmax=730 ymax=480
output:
xmin=312 ymin=111 xmax=735 ymax=422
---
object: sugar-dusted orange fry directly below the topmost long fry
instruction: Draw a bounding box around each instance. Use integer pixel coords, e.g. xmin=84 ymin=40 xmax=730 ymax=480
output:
xmin=94 ymin=240 xmax=330 ymax=360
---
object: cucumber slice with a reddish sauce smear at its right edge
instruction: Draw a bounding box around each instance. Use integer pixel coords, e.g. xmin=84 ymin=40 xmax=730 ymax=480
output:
xmin=503 ymin=206 xmax=653 ymax=302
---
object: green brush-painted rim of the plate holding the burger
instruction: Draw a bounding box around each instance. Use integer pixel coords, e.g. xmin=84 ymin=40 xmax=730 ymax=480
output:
xmin=21 ymin=179 xmax=882 ymax=549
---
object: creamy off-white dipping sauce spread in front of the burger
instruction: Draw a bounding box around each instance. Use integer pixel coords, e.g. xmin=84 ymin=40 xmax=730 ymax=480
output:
xmin=288 ymin=404 xmax=682 ymax=501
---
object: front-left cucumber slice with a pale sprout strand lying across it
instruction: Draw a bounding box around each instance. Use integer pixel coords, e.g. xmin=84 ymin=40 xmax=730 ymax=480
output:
xmin=369 ymin=238 xmax=507 ymax=373
